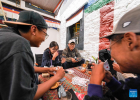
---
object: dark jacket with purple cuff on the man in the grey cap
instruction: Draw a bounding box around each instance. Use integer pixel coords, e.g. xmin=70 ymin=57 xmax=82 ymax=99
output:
xmin=85 ymin=77 xmax=140 ymax=100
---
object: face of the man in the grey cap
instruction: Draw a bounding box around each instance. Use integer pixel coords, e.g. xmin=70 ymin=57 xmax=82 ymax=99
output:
xmin=110 ymin=35 xmax=140 ymax=74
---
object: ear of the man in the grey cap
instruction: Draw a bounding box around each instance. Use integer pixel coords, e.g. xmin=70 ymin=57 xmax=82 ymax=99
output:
xmin=124 ymin=32 xmax=137 ymax=51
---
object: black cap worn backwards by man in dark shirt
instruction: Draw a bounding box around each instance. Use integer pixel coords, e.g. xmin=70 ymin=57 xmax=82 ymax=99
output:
xmin=4 ymin=11 xmax=48 ymax=29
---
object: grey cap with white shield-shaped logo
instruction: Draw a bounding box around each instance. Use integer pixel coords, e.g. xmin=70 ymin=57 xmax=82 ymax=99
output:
xmin=100 ymin=6 xmax=140 ymax=39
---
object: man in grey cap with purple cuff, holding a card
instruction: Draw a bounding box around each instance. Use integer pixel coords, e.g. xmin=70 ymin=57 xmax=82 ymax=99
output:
xmin=85 ymin=6 xmax=140 ymax=100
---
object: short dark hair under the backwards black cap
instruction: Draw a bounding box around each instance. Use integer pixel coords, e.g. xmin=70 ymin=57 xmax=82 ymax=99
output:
xmin=17 ymin=25 xmax=44 ymax=33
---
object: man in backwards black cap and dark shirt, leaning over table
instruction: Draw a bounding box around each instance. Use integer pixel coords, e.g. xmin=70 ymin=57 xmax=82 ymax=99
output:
xmin=0 ymin=11 xmax=65 ymax=100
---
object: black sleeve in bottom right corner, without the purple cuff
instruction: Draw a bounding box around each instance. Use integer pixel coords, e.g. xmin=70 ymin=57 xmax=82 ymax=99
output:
xmin=107 ymin=78 xmax=140 ymax=100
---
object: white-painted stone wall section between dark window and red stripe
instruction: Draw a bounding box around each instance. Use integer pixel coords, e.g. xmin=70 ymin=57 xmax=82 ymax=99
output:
xmin=81 ymin=10 xmax=100 ymax=60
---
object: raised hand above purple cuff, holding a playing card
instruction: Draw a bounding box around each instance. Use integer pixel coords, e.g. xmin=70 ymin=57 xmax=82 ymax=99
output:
xmin=90 ymin=62 xmax=105 ymax=85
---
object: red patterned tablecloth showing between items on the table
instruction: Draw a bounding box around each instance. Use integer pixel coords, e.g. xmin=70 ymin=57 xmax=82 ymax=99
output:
xmin=39 ymin=67 xmax=106 ymax=100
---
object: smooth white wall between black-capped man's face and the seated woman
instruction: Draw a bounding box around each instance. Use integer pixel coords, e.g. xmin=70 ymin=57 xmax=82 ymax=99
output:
xmin=31 ymin=28 xmax=60 ymax=61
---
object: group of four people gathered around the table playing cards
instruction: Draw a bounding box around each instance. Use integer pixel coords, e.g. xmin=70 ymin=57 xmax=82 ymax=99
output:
xmin=0 ymin=6 xmax=140 ymax=100
